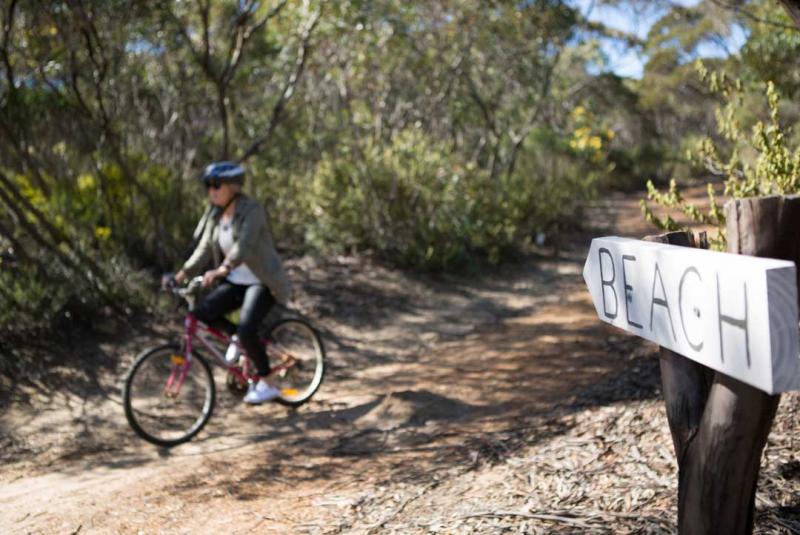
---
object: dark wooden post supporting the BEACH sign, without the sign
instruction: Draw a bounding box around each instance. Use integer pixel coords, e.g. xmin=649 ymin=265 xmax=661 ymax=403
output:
xmin=645 ymin=196 xmax=800 ymax=535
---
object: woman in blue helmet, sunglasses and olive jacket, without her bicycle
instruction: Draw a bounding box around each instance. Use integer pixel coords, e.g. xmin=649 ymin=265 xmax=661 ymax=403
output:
xmin=175 ymin=162 xmax=291 ymax=404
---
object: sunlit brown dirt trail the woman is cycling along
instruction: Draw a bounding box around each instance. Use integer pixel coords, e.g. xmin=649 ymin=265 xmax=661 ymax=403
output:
xmin=0 ymin=191 xmax=752 ymax=533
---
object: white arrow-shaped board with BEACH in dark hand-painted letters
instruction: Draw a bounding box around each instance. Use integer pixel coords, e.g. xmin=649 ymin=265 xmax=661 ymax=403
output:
xmin=583 ymin=237 xmax=800 ymax=394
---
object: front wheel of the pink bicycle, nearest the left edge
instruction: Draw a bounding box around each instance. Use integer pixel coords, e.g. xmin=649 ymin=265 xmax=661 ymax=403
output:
xmin=122 ymin=345 xmax=216 ymax=447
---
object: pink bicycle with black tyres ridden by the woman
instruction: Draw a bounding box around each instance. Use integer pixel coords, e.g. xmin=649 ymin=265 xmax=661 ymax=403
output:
xmin=122 ymin=277 xmax=325 ymax=447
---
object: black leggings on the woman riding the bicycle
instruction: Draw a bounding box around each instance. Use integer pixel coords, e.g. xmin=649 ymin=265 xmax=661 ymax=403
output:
xmin=193 ymin=281 xmax=275 ymax=376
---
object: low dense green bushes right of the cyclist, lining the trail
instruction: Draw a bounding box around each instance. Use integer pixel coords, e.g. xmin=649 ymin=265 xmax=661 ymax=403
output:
xmin=305 ymin=124 xmax=595 ymax=269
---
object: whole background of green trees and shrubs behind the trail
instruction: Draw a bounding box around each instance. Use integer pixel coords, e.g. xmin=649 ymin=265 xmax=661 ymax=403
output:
xmin=0 ymin=0 xmax=800 ymax=370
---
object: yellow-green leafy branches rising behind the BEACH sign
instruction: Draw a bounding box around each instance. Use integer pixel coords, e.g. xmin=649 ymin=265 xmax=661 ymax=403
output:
xmin=642 ymin=62 xmax=800 ymax=249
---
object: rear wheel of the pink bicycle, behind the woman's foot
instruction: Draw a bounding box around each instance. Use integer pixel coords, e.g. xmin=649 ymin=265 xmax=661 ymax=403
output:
xmin=268 ymin=319 xmax=325 ymax=406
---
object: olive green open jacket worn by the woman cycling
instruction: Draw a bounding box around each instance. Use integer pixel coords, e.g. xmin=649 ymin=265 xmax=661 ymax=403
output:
xmin=182 ymin=194 xmax=291 ymax=304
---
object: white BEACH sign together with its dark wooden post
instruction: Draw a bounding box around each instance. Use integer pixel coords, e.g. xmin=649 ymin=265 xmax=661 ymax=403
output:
xmin=584 ymin=196 xmax=800 ymax=535
